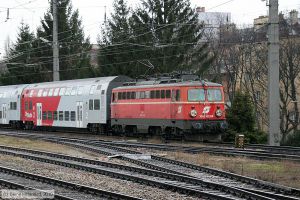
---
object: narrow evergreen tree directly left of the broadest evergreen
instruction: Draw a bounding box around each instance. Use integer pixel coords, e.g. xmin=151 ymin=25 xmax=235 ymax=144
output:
xmin=98 ymin=0 xmax=133 ymax=76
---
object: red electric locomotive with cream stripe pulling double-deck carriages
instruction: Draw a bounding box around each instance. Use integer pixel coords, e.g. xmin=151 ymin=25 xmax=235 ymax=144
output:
xmin=111 ymin=76 xmax=227 ymax=141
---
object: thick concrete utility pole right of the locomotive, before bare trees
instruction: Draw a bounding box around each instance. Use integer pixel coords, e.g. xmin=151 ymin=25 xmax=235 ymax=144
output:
xmin=268 ymin=0 xmax=280 ymax=146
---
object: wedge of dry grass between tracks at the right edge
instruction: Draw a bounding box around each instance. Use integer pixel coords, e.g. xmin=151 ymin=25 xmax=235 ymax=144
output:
xmin=168 ymin=152 xmax=300 ymax=188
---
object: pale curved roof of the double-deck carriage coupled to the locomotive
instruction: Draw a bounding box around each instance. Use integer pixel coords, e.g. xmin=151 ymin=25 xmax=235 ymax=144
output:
xmin=26 ymin=76 xmax=130 ymax=89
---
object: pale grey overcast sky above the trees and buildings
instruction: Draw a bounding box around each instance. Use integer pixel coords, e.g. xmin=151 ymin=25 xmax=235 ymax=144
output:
xmin=0 ymin=0 xmax=300 ymax=57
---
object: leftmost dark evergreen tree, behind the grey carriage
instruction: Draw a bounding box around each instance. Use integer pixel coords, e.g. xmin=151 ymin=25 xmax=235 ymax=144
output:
xmin=1 ymin=22 xmax=43 ymax=84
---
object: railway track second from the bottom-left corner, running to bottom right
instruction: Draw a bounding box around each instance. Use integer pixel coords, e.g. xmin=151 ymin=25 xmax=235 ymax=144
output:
xmin=0 ymin=146 xmax=274 ymax=199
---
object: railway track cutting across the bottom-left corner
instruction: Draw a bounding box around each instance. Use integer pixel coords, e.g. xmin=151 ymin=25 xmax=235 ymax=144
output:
xmin=0 ymin=166 xmax=142 ymax=200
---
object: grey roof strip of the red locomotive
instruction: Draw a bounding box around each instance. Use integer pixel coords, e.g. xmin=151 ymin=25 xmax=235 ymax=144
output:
xmin=115 ymin=81 xmax=222 ymax=90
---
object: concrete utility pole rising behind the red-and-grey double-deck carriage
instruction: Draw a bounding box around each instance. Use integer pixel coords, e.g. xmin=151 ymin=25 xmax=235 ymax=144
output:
xmin=52 ymin=0 xmax=59 ymax=81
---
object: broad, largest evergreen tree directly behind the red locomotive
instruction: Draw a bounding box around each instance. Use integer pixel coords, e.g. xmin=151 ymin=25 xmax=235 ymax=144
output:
xmin=131 ymin=0 xmax=213 ymax=73
